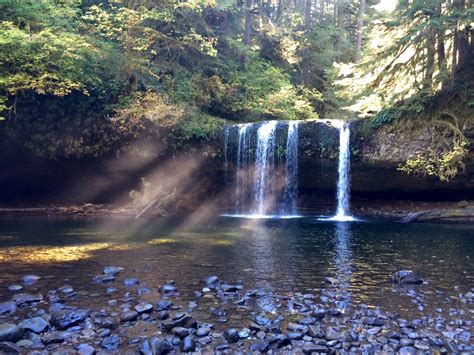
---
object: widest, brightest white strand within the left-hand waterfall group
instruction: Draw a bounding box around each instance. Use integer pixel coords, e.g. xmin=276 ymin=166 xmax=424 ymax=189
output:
xmin=253 ymin=121 xmax=278 ymax=215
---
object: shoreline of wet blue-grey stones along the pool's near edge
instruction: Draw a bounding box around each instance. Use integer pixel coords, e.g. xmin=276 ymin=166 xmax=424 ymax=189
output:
xmin=0 ymin=266 xmax=474 ymax=355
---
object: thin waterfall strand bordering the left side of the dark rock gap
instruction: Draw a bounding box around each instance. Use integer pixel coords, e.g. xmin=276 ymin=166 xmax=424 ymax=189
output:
xmin=282 ymin=121 xmax=299 ymax=215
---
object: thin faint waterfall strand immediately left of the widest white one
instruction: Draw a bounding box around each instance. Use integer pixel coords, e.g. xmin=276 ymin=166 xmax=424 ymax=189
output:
xmin=235 ymin=123 xmax=252 ymax=213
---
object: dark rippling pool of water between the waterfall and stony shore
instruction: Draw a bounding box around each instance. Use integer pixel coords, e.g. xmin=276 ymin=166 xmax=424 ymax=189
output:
xmin=0 ymin=217 xmax=474 ymax=315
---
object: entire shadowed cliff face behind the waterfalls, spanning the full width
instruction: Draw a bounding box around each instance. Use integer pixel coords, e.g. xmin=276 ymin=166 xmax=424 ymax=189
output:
xmin=0 ymin=121 xmax=474 ymax=206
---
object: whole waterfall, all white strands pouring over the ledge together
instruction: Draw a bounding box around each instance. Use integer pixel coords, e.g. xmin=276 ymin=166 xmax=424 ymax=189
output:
xmin=224 ymin=120 xmax=354 ymax=221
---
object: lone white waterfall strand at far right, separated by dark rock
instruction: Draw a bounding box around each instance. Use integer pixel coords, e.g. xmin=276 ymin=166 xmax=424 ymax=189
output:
xmin=331 ymin=121 xmax=354 ymax=221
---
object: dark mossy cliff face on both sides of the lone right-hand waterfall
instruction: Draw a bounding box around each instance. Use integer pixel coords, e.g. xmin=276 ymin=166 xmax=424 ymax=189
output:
xmin=300 ymin=120 xmax=474 ymax=200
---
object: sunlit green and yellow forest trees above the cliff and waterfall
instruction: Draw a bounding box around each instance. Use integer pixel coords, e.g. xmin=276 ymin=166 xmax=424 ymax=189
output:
xmin=0 ymin=0 xmax=474 ymax=161
